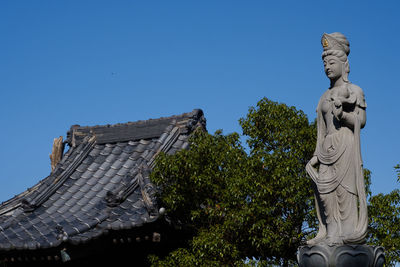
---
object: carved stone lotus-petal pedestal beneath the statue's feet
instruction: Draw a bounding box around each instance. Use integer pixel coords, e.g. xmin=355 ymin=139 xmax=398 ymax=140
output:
xmin=297 ymin=245 xmax=385 ymax=267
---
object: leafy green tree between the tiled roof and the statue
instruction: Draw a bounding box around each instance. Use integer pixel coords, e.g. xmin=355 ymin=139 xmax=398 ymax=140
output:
xmin=151 ymin=98 xmax=316 ymax=266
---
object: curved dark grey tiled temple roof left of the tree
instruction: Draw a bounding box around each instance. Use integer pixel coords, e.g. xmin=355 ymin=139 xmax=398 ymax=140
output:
xmin=0 ymin=110 xmax=205 ymax=252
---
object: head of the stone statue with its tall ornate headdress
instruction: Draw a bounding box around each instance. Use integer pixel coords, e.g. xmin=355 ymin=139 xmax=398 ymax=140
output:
xmin=321 ymin=32 xmax=350 ymax=82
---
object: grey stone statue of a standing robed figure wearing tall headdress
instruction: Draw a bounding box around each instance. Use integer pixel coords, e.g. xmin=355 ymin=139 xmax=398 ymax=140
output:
xmin=306 ymin=32 xmax=368 ymax=245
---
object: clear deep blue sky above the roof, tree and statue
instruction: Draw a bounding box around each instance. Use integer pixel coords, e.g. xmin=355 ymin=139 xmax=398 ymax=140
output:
xmin=0 ymin=0 xmax=400 ymax=201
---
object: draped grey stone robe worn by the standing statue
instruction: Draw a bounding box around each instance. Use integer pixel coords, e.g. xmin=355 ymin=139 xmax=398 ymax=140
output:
xmin=306 ymin=84 xmax=368 ymax=243
